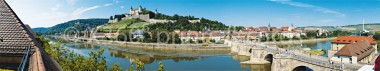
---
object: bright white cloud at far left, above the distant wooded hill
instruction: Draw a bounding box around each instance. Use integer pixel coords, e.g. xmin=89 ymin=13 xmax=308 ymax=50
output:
xmin=7 ymin=0 xmax=114 ymax=28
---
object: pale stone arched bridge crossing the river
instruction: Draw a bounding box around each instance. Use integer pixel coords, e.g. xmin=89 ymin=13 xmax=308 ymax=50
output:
xmin=225 ymin=41 xmax=361 ymax=71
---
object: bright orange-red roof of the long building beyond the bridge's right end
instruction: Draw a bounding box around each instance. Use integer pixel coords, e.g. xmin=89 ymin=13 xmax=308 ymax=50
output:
xmin=332 ymin=36 xmax=377 ymax=45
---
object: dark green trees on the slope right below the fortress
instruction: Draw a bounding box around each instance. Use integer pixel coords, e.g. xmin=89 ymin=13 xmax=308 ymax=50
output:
xmin=143 ymin=10 xmax=229 ymax=31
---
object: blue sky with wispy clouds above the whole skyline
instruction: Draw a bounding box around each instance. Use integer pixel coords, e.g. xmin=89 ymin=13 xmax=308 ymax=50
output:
xmin=6 ymin=0 xmax=380 ymax=27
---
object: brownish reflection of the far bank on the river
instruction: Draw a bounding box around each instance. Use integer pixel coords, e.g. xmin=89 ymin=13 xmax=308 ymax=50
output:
xmin=66 ymin=43 xmax=230 ymax=57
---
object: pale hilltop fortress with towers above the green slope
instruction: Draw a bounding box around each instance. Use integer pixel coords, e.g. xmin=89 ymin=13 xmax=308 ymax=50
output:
xmin=108 ymin=5 xmax=200 ymax=23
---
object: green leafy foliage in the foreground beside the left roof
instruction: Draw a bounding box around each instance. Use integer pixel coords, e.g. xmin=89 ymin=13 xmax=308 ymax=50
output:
xmin=40 ymin=36 xmax=163 ymax=71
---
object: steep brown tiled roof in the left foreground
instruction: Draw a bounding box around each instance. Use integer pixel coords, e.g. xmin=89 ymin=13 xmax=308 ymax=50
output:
xmin=0 ymin=0 xmax=41 ymax=54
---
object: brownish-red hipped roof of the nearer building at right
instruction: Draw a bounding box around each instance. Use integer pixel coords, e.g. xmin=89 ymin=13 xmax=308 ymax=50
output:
xmin=335 ymin=40 xmax=375 ymax=60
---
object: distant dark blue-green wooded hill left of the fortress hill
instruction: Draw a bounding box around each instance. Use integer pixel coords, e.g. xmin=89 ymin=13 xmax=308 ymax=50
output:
xmin=33 ymin=18 xmax=108 ymax=35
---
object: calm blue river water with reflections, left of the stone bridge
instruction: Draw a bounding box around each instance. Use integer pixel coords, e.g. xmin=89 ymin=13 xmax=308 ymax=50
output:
xmin=59 ymin=42 xmax=271 ymax=71
